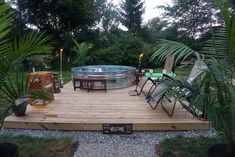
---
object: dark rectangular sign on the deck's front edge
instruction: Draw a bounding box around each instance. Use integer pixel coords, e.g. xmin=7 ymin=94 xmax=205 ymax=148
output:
xmin=103 ymin=124 xmax=132 ymax=134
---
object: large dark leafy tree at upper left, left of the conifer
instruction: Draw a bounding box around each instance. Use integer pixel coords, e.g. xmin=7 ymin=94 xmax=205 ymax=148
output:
xmin=16 ymin=0 xmax=97 ymax=62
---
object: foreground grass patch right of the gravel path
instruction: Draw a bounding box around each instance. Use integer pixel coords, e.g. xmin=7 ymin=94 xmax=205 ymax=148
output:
xmin=159 ymin=136 xmax=224 ymax=157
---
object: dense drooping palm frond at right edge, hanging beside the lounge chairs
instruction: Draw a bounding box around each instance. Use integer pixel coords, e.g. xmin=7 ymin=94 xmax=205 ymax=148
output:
xmin=200 ymin=59 xmax=235 ymax=142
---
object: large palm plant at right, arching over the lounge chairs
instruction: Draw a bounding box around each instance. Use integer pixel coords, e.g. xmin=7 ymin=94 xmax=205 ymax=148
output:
xmin=151 ymin=0 xmax=235 ymax=153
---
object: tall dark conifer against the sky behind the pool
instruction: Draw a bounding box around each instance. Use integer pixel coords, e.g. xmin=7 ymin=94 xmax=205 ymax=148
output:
xmin=120 ymin=0 xmax=144 ymax=33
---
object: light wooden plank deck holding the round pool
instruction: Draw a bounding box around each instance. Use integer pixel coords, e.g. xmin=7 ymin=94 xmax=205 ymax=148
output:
xmin=3 ymin=82 xmax=210 ymax=131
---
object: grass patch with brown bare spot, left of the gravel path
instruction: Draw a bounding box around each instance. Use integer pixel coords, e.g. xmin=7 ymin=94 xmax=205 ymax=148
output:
xmin=0 ymin=136 xmax=77 ymax=157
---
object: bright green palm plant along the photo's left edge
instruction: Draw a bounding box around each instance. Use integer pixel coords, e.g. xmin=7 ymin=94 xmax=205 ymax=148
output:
xmin=0 ymin=0 xmax=52 ymax=127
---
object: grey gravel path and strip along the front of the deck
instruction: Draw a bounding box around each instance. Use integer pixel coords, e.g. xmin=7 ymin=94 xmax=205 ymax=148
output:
xmin=0 ymin=129 xmax=216 ymax=157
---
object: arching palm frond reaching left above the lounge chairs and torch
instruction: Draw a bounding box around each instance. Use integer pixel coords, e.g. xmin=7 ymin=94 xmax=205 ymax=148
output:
xmin=150 ymin=40 xmax=200 ymax=63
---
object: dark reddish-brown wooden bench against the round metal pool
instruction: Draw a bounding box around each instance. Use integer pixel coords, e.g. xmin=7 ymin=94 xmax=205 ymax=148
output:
xmin=73 ymin=76 xmax=107 ymax=92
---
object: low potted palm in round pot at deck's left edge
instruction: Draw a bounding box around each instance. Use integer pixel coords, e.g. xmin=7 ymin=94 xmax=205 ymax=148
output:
xmin=0 ymin=71 xmax=53 ymax=116
